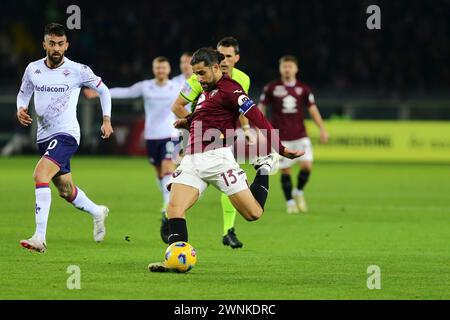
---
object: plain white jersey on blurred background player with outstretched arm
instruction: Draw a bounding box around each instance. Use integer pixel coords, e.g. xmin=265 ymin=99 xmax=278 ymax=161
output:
xmin=109 ymin=79 xmax=180 ymax=140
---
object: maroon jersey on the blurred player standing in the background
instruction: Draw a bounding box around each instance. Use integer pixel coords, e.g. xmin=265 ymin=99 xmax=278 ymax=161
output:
xmin=260 ymin=80 xmax=315 ymax=141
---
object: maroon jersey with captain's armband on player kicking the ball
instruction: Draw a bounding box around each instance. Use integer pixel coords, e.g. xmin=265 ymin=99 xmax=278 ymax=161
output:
xmin=186 ymin=75 xmax=284 ymax=154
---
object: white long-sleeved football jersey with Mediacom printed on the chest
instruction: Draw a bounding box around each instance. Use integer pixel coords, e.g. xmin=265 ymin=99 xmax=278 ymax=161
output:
xmin=17 ymin=57 xmax=102 ymax=144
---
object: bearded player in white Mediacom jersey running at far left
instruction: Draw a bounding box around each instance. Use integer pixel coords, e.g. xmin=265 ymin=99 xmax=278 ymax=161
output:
xmin=17 ymin=23 xmax=113 ymax=252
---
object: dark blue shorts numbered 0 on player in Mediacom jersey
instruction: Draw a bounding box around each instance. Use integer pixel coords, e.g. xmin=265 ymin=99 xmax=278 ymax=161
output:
xmin=38 ymin=135 xmax=78 ymax=175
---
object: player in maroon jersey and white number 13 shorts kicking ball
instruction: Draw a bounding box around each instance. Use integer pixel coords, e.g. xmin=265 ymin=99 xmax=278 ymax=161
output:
xmin=148 ymin=48 xmax=304 ymax=272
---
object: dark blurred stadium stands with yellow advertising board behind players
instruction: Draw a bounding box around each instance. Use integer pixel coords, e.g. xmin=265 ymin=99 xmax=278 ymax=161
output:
xmin=0 ymin=0 xmax=450 ymax=162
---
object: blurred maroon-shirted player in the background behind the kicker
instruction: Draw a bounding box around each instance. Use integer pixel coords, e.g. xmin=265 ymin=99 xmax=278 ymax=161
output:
xmin=258 ymin=56 xmax=328 ymax=213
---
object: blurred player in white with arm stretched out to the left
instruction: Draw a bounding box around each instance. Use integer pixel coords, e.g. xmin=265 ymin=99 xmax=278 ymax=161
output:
xmin=84 ymin=57 xmax=180 ymax=240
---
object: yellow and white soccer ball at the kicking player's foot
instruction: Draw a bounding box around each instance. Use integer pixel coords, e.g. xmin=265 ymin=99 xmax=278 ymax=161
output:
xmin=164 ymin=241 xmax=197 ymax=272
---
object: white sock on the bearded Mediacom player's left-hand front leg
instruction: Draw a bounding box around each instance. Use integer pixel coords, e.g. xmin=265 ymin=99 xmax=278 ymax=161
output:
xmin=35 ymin=183 xmax=52 ymax=241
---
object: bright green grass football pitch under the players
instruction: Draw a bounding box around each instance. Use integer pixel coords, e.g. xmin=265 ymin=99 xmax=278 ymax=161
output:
xmin=0 ymin=156 xmax=450 ymax=300
